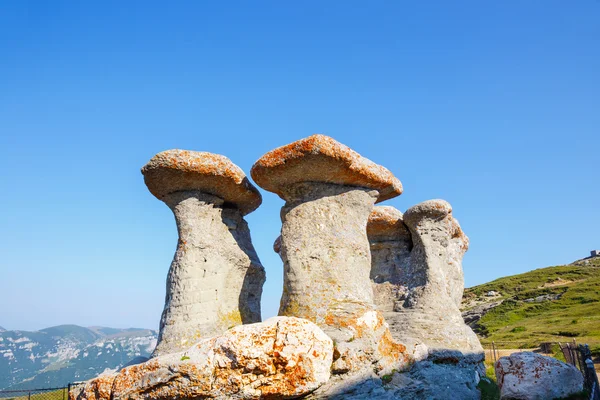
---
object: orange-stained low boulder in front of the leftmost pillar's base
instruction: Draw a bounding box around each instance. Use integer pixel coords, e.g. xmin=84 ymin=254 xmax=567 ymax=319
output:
xmin=69 ymin=317 xmax=333 ymax=400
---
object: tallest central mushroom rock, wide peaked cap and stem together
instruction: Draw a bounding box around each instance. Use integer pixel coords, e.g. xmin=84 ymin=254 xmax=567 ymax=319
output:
xmin=251 ymin=135 xmax=406 ymax=374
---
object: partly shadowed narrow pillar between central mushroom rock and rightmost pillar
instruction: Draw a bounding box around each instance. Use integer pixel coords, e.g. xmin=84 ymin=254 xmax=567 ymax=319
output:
xmin=367 ymin=206 xmax=412 ymax=311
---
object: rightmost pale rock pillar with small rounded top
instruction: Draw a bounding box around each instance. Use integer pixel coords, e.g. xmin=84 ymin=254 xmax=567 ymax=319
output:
xmin=385 ymin=200 xmax=483 ymax=358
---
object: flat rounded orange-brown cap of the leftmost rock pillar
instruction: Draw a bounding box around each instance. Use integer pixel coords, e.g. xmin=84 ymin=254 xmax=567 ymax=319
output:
xmin=142 ymin=149 xmax=262 ymax=215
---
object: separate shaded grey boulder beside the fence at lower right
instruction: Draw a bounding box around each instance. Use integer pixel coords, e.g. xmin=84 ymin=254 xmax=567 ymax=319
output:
xmin=495 ymin=351 xmax=583 ymax=400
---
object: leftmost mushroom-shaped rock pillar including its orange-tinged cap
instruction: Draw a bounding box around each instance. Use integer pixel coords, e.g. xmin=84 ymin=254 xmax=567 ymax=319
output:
xmin=142 ymin=150 xmax=265 ymax=356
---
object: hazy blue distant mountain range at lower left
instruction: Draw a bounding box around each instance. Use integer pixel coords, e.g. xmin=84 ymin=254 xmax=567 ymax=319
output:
xmin=0 ymin=325 xmax=157 ymax=390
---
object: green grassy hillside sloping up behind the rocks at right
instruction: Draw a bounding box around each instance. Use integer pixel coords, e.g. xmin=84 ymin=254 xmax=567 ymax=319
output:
xmin=462 ymin=257 xmax=600 ymax=347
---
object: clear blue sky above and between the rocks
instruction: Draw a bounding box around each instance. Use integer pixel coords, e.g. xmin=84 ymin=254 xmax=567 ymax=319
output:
xmin=0 ymin=0 xmax=600 ymax=329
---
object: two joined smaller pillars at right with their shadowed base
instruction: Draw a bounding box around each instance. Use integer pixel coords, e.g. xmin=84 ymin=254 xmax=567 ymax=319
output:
xmin=367 ymin=200 xmax=484 ymax=399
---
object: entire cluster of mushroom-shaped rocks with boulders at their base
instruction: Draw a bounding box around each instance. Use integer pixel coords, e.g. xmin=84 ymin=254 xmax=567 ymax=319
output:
xmin=70 ymin=135 xmax=492 ymax=400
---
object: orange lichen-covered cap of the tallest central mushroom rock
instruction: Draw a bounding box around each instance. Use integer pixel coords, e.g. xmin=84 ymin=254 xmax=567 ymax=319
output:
xmin=250 ymin=135 xmax=402 ymax=202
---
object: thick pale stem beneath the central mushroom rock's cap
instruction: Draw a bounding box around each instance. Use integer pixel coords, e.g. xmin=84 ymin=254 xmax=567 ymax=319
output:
xmin=270 ymin=183 xmax=409 ymax=374
